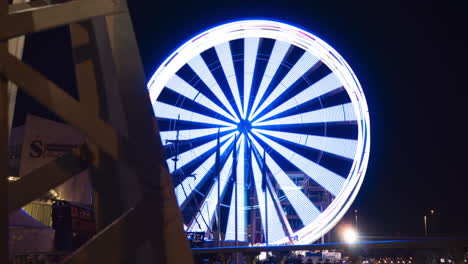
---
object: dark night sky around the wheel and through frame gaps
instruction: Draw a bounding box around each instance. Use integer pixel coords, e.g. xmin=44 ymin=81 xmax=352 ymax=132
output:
xmin=15 ymin=0 xmax=468 ymax=236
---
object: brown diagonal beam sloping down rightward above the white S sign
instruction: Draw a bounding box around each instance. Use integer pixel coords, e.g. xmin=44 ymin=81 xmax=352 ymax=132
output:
xmin=0 ymin=52 xmax=119 ymax=159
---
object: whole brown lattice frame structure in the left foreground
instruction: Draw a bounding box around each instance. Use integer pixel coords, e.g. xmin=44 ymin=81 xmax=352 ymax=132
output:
xmin=0 ymin=0 xmax=192 ymax=264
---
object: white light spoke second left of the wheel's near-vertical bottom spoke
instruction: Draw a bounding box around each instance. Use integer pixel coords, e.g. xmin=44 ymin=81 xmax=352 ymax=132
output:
xmin=175 ymin=134 xmax=234 ymax=206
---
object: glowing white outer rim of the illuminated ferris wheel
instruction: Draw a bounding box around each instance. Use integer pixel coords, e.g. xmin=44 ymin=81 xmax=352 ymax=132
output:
xmin=148 ymin=20 xmax=370 ymax=244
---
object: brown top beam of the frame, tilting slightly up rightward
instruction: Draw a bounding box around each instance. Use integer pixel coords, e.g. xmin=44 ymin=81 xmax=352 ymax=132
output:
xmin=0 ymin=0 xmax=127 ymax=40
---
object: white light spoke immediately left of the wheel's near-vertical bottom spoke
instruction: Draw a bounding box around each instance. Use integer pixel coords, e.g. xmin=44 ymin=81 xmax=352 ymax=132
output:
xmin=189 ymin=150 xmax=232 ymax=232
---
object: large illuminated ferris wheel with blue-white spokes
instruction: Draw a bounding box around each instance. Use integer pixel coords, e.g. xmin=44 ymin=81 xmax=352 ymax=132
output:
xmin=148 ymin=20 xmax=370 ymax=244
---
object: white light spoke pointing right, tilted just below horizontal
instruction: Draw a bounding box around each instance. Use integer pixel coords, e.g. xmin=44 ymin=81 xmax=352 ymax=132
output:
xmin=255 ymin=129 xmax=357 ymax=159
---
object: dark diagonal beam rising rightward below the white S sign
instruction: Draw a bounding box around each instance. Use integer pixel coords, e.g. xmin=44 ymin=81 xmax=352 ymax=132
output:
xmin=8 ymin=145 xmax=88 ymax=213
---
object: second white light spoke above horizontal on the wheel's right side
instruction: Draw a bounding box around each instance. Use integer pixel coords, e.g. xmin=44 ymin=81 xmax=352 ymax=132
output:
xmin=255 ymin=73 xmax=342 ymax=122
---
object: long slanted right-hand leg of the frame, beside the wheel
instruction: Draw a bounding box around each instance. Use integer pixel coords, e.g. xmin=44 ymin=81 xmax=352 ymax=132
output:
xmin=101 ymin=10 xmax=193 ymax=264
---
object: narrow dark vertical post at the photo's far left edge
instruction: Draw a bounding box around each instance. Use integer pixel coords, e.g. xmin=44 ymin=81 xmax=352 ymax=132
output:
xmin=0 ymin=0 xmax=8 ymax=263
